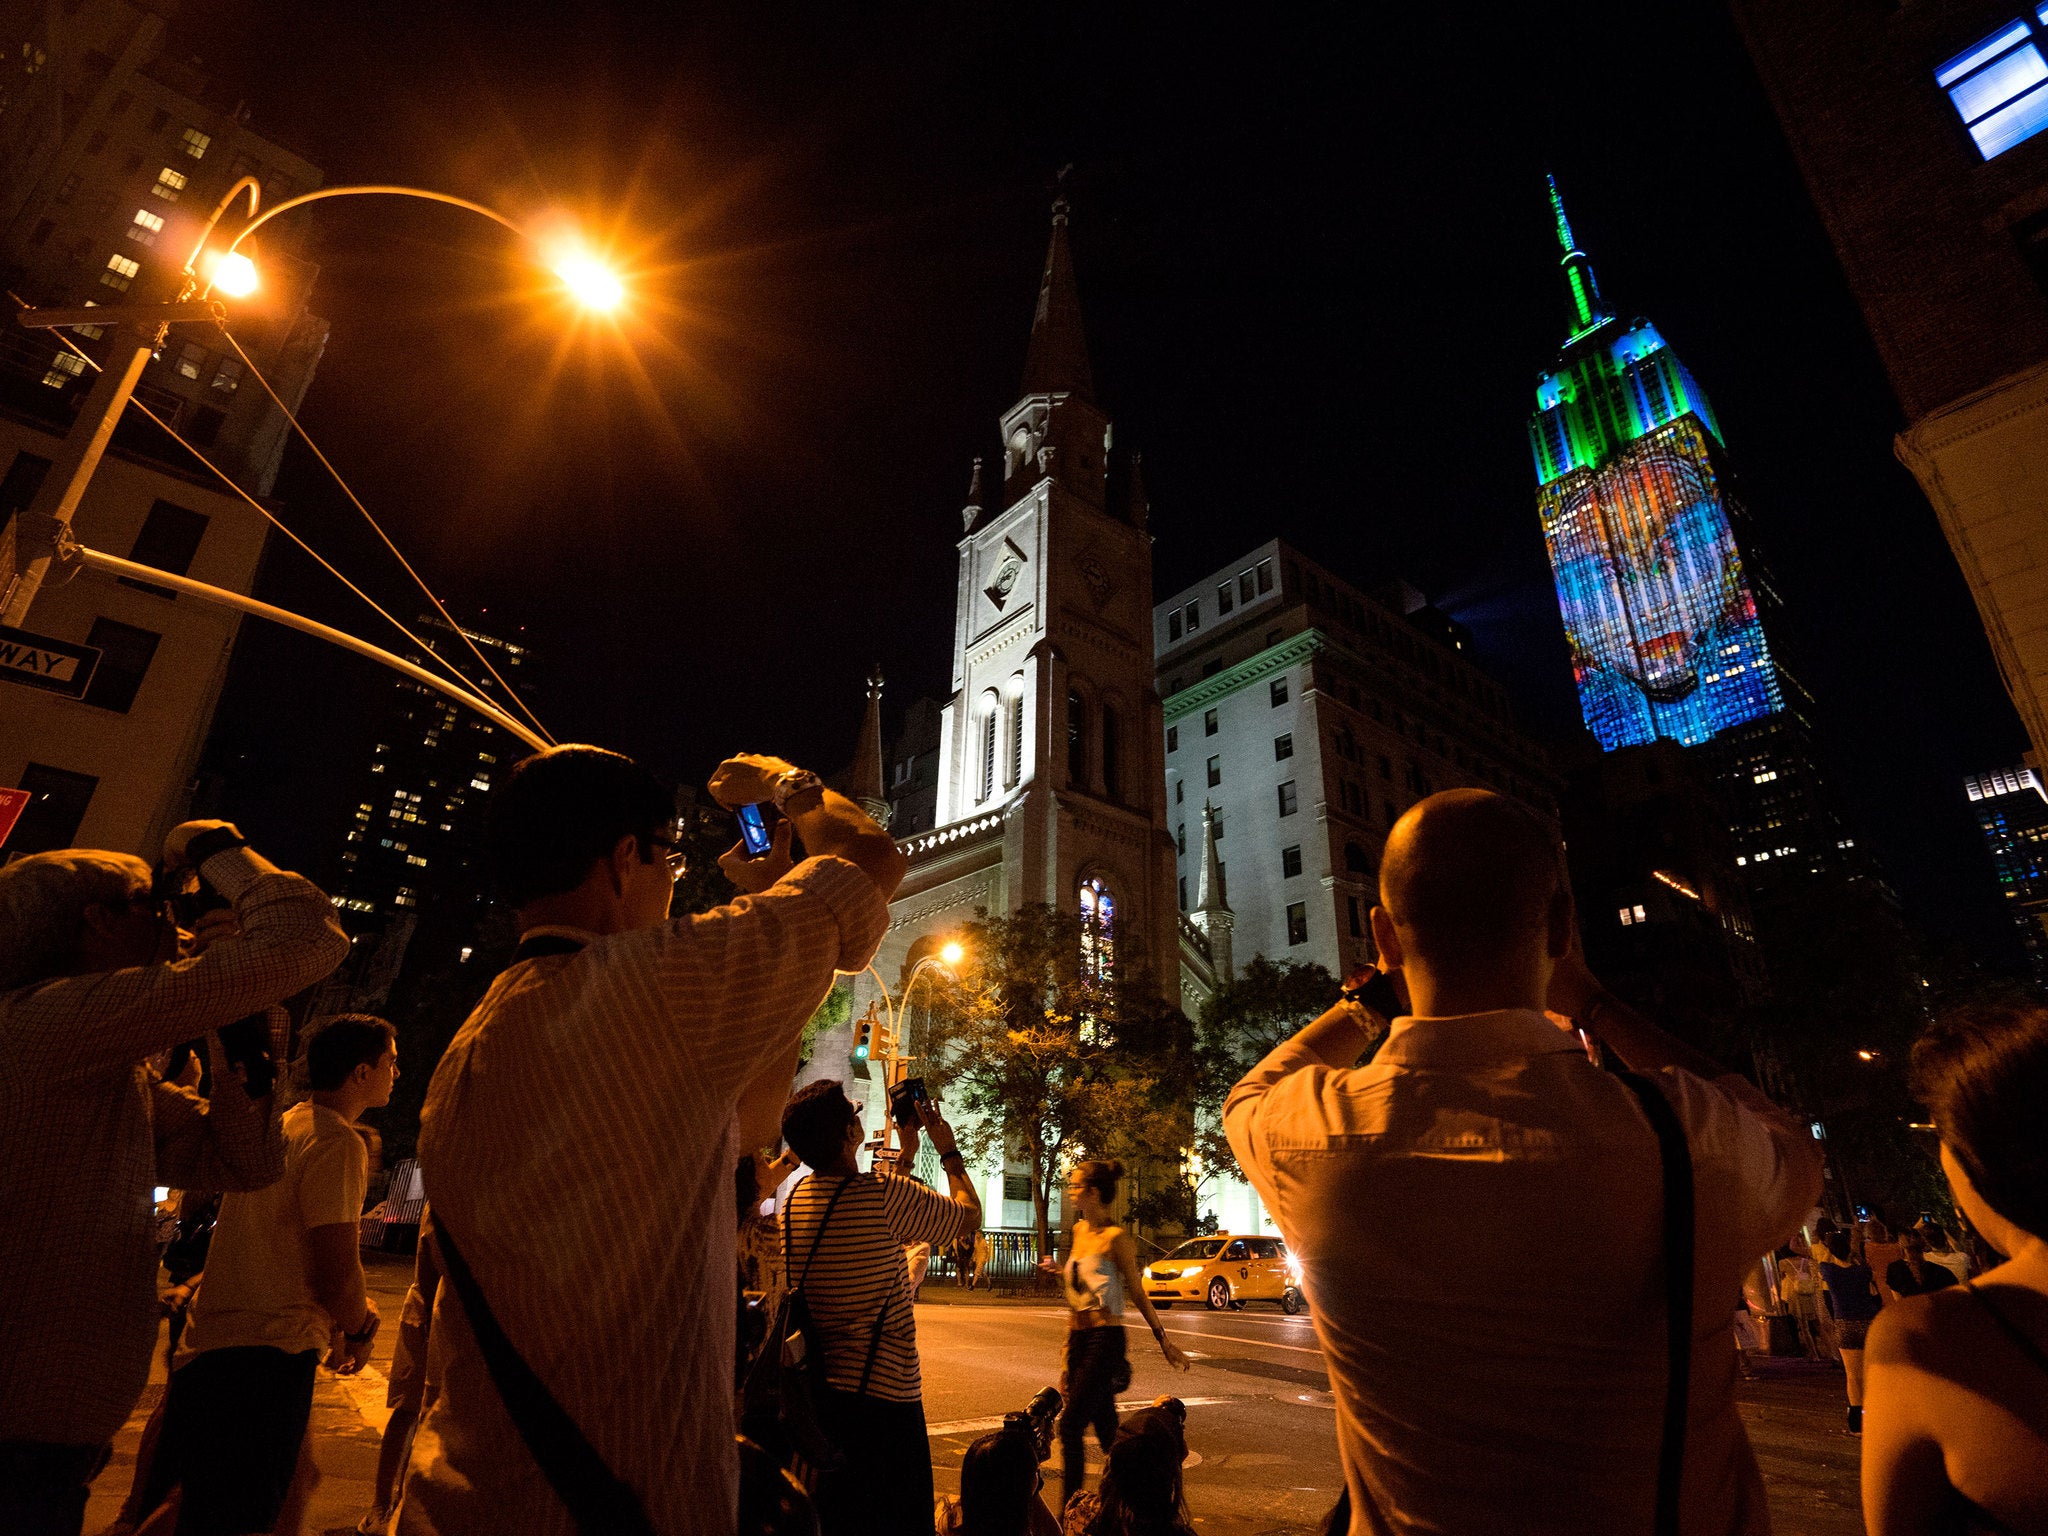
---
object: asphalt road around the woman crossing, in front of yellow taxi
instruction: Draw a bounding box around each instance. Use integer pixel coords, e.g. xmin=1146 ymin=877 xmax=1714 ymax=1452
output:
xmin=918 ymin=1292 xmax=1343 ymax=1536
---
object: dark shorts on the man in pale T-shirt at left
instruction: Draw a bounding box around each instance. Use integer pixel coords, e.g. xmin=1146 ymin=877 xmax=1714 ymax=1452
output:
xmin=156 ymin=1346 xmax=319 ymax=1536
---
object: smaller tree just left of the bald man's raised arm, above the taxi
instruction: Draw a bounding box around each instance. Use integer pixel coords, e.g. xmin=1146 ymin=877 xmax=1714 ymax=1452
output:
xmin=1182 ymin=954 xmax=1337 ymax=1233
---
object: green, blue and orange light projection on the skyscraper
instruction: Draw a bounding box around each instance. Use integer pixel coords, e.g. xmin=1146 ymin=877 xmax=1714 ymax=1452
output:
xmin=1530 ymin=180 xmax=1784 ymax=752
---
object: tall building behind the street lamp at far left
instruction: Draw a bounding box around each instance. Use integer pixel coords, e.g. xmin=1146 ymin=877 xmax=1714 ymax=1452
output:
xmin=0 ymin=0 xmax=328 ymax=856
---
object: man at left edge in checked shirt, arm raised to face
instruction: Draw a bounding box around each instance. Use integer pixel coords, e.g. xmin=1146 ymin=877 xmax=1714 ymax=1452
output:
xmin=0 ymin=821 xmax=348 ymax=1536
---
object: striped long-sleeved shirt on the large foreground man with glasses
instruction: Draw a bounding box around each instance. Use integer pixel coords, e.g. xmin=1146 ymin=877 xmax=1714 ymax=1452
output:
xmin=399 ymin=858 xmax=889 ymax=1536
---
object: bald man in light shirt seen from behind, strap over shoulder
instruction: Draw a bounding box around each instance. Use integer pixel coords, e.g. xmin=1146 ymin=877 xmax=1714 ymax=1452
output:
xmin=1225 ymin=791 xmax=1821 ymax=1536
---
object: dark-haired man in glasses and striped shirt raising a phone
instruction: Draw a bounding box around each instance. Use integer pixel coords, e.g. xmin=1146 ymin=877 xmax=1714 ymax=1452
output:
xmin=397 ymin=748 xmax=905 ymax=1536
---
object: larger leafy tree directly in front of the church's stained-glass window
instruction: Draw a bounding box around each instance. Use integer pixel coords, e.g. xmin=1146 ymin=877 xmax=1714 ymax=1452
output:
xmin=926 ymin=905 xmax=1190 ymax=1253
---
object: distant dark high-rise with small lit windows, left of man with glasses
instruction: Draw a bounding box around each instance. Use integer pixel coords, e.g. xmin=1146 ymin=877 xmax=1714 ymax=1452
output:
xmin=334 ymin=616 xmax=532 ymax=1008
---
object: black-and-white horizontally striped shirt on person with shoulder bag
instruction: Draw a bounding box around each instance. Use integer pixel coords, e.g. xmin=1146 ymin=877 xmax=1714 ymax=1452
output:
xmin=782 ymin=1174 xmax=977 ymax=1403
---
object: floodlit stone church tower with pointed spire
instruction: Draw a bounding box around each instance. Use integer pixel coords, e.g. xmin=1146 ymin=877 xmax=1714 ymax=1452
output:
xmin=860 ymin=199 xmax=1182 ymax=1024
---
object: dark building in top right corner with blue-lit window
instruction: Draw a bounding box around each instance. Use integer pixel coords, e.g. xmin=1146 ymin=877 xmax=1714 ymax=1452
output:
xmin=1735 ymin=0 xmax=2048 ymax=782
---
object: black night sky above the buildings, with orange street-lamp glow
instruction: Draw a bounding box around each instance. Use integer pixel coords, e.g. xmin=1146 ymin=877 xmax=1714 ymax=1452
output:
xmin=184 ymin=0 xmax=2025 ymax=962
